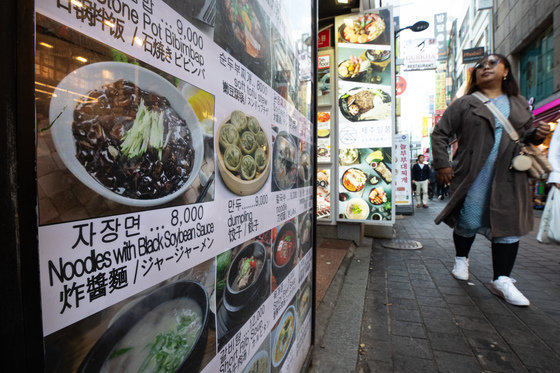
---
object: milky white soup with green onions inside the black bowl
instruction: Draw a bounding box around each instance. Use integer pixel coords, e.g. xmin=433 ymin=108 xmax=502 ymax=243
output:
xmin=101 ymin=298 xmax=202 ymax=373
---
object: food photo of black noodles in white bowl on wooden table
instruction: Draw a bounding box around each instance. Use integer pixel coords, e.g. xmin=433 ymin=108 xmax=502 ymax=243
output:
xmin=35 ymin=16 xmax=214 ymax=224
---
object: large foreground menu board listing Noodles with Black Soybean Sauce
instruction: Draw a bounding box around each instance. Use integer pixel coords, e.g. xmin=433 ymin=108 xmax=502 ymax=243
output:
xmin=35 ymin=0 xmax=316 ymax=372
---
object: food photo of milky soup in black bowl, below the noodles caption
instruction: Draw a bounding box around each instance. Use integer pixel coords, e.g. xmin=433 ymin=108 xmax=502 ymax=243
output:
xmin=45 ymin=259 xmax=216 ymax=372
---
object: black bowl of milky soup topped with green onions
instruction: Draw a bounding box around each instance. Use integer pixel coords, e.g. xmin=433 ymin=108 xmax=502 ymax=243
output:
xmin=78 ymin=281 xmax=209 ymax=373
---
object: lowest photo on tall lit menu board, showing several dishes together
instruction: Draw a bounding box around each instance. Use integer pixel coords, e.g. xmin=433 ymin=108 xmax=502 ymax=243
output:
xmin=338 ymin=147 xmax=392 ymax=221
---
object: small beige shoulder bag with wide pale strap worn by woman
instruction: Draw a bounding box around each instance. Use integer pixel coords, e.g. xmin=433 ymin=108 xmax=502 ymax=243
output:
xmin=472 ymin=91 xmax=552 ymax=179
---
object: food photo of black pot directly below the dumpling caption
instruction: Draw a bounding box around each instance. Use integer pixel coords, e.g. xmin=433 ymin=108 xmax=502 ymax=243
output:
xmin=216 ymin=231 xmax=271 ymax=349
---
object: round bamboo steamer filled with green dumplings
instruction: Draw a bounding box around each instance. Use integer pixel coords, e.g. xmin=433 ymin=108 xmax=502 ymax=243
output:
xmin=214 ymin=110 xmax=270 ymax=196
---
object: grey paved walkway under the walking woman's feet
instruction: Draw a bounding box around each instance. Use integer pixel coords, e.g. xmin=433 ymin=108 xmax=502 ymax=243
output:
xmin=311 ymin=196 xmax=560 ymax=373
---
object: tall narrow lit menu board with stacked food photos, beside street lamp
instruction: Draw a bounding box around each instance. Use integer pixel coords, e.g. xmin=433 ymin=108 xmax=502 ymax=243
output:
xmin=335 ymin=9 xmax=395 ymax=224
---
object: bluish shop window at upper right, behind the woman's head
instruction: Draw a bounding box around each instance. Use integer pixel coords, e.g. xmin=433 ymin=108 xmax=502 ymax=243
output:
xmin=519 ymin=26 xmax=554 ymax=102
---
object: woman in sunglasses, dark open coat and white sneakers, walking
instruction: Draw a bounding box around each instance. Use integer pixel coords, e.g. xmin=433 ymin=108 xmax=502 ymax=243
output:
xmin=431 ymin=54 xmax=550 ymax=306
